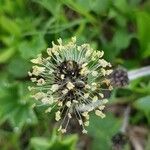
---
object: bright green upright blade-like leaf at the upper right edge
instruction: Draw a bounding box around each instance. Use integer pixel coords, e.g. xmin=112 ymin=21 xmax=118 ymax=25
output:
xmin=137 ymin=12 xmax=150 ymax=57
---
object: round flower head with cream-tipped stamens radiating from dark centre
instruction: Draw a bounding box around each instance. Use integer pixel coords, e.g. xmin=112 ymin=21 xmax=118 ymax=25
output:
xmin=29 ymin=38 xmax=112 ymax=133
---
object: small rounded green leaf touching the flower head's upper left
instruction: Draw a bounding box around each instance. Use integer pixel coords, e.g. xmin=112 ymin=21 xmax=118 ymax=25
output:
xmin=19 ymin=35 xmax=46 ymax=59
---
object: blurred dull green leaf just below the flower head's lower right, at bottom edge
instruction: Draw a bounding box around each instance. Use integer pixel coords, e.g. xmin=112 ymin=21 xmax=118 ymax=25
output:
xmin=88 ymin=114 xmax=121 ymax=150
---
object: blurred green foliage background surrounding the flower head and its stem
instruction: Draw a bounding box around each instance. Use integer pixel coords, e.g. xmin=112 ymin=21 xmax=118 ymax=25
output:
xmin=0 ymin=0 xmax=150 ymax=150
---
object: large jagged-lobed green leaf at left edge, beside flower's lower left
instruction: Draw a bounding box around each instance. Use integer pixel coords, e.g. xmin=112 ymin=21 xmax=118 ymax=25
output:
xmin=0 ymin=83 xmax=37 ymax=130
